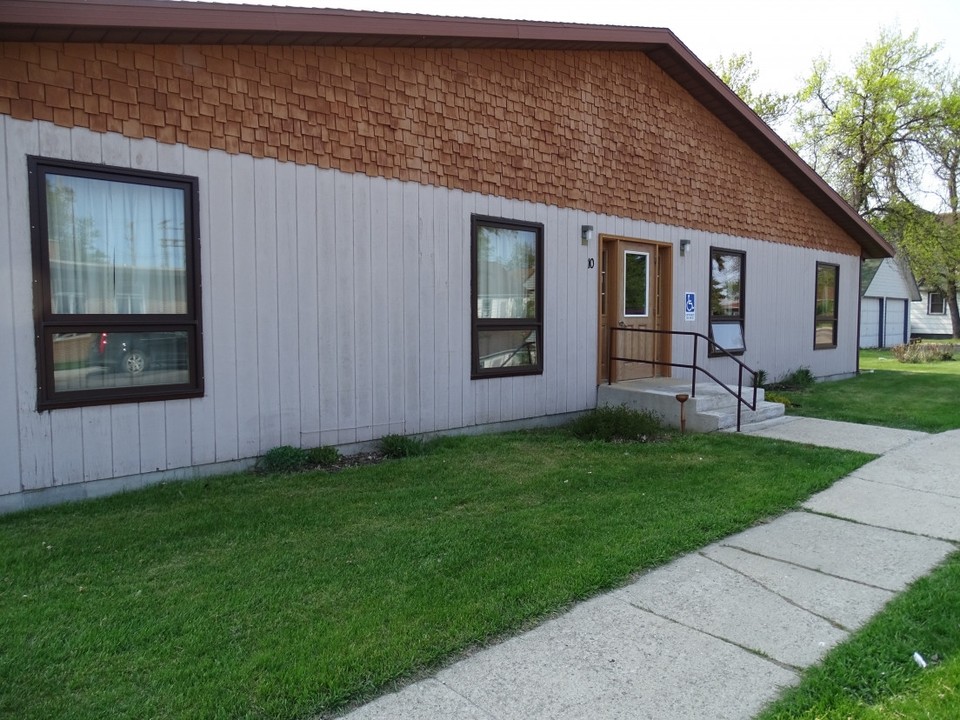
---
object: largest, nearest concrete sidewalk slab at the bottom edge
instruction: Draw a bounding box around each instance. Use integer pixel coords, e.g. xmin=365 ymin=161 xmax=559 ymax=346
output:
xmin=364 ymin=596 xmax=796 ymax=720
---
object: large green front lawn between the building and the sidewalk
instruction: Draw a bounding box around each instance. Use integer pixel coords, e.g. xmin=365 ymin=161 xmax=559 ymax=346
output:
xmin=0 ymin=431 xmax=868 ymax=720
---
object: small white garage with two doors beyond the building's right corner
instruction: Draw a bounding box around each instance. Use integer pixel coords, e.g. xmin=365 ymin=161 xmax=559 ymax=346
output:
xmin=860 ymin=258 xmax=920 ymax=348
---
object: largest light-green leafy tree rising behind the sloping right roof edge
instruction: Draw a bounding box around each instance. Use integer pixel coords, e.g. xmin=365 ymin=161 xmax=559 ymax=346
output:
xmin=795 ymin=30 xmax=942 ymax=219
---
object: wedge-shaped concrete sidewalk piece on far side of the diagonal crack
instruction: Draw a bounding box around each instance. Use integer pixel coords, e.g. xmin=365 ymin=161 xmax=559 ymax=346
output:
xmin=702 ymin=543 xmax=894 ymax=630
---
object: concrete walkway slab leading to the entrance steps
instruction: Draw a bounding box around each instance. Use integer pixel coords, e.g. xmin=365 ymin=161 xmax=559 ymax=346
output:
xmin=742 ymin=415 xmax=927 ymax=455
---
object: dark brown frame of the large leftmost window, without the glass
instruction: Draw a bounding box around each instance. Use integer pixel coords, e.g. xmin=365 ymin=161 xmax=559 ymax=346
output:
xmin=27 ymin=156 xmax=204 ymax=411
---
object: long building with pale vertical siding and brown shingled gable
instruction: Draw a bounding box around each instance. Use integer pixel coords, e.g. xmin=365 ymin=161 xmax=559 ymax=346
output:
xmin=0 ymin=0 xmax=892 ymax=510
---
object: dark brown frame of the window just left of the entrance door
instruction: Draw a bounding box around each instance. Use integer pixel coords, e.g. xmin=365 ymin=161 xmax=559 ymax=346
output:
xmin=470 ymin=215 xmax=544 ymax=380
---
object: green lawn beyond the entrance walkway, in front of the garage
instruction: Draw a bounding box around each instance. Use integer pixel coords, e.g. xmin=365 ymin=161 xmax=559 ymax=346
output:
xmin=778 ymin=350 xmax=960 ymax=432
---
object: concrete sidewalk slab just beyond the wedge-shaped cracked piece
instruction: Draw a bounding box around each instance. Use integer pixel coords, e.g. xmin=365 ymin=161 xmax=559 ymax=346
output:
xmin=723 ymin=512 xmax=955 ymax=592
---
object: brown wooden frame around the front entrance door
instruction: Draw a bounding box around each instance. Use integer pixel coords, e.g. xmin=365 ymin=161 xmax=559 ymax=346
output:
xmin=597 ymin=234 xmax=674 ymax=385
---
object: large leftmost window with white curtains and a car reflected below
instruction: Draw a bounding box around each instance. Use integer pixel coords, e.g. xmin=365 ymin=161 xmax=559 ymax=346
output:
xmin=29 ymin=158 xmax=203 ymax=409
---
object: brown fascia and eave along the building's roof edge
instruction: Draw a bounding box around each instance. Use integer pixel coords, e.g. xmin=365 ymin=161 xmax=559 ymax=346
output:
xmin=0 ymin=0 xmax=894 ymax=258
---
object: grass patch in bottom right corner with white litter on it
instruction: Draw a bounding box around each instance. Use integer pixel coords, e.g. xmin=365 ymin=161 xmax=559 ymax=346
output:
xmin=758 ymin=554 xmax=960 ymax=720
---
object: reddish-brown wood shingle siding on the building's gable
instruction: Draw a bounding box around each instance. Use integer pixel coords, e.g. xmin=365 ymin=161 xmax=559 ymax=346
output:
xmin=0 ymin=42 xmax=860 ymax=254
